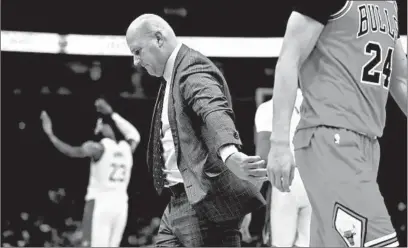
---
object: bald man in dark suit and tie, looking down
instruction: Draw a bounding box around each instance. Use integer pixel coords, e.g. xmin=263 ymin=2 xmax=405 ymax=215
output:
xmin=126 ymin=14 xmax=267 ymax=247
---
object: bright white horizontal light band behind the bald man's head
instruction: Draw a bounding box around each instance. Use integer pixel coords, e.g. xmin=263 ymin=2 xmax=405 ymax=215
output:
xmin=1 ymin=31 xmax=407 ymax=58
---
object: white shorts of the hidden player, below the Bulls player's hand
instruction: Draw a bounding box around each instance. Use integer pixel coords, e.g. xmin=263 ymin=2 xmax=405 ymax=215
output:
xmin=270 ymin=169 xmax=312 ymax=247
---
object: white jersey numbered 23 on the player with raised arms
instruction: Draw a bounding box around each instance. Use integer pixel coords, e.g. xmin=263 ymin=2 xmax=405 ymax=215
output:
xmin=85 ymin=138 xmax=133 ymax=200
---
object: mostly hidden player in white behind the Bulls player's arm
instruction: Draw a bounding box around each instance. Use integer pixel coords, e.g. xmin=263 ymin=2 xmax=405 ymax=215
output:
xmin=250 ymin=89 xmax=312 ymax=247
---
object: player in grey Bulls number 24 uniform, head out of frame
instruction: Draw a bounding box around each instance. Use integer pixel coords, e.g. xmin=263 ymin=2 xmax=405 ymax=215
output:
xmin=268 ymin=1 xmax=407 ymax=247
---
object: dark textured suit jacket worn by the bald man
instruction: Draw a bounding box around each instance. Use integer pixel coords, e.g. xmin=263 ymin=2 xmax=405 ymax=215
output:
xmin=147 ymin=45 xmax=265 ymax=222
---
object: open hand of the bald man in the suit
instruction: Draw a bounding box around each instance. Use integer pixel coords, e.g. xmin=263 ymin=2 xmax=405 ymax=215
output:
xmin=225 ymin=152 xmax=268 ymax=185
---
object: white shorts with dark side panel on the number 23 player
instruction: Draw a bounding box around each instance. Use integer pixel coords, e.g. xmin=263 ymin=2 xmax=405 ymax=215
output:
xmin=82 ymin=195 xmax=128 ymax=247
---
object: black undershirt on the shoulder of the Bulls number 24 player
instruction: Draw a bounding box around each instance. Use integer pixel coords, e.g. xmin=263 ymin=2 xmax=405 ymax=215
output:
xmin=293 ymin=0 xmax=351 ymax=25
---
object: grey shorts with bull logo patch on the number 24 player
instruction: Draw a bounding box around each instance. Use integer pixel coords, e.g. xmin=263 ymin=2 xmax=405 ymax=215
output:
xmin=294 ymin=126 xmax=398 ymax=247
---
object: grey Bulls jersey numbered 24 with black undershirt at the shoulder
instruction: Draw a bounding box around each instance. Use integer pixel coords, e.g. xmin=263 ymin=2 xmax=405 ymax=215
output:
xmin=295 ymin=1 xmax=398 ymax=137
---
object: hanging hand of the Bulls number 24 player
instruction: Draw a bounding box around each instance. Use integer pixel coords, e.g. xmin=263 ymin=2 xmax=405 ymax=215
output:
xmin=267 ymin=141 xmax=295 ymax=192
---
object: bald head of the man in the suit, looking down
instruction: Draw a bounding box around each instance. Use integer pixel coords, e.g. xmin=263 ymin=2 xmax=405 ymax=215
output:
xmin=126 ymin=14 xmax=177 ymax=77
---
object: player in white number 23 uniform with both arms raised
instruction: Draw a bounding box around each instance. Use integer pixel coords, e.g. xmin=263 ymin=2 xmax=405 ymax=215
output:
xmin=41 ymin=99 xmax=140 ymax=247
